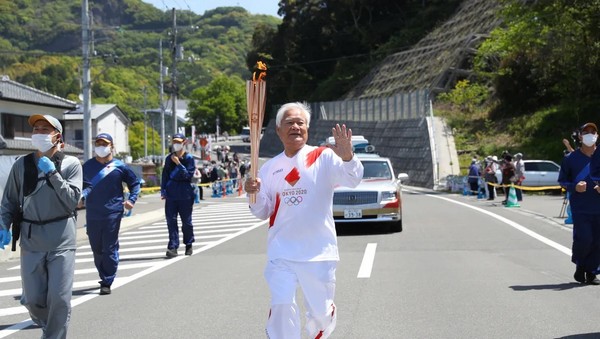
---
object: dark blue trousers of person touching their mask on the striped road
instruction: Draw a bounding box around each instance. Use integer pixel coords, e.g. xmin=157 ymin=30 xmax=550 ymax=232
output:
xmin=165 ymin=198 xmax=195 ymax=249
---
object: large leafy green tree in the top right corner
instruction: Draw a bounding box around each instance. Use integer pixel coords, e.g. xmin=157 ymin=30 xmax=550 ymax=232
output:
xmin=475 ymin=0 xmax=600 ymax=115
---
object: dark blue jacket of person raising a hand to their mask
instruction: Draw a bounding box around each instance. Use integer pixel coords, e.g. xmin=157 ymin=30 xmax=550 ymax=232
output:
xmin=160 ymin=152 xmax=196 ymax=200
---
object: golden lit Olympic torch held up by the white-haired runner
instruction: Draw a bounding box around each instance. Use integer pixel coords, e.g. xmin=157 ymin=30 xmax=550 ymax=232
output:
xmin=246 ymin=61 xmax=267 ymax=204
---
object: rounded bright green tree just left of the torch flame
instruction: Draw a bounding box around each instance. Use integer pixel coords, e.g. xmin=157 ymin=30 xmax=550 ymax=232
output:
xmin=188 ymin=75 xmax=248 ymax=134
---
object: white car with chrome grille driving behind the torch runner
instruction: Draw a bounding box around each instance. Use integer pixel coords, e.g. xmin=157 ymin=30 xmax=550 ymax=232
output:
xmin=333 ymin=153 xmax=408 ymax=232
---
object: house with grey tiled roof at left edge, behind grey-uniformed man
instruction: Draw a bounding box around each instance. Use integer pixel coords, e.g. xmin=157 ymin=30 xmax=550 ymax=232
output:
xmin=0 ymin=75 xmax=83 ymax=157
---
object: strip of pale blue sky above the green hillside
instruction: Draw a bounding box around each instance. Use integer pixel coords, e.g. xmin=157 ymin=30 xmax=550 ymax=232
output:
xmin=142 ymin=0 xmax=279 ymax=16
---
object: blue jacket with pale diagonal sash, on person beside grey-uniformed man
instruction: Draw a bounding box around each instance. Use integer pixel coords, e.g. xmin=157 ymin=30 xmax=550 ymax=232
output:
xmin=83 ymin=158 xmax=140 ymax=220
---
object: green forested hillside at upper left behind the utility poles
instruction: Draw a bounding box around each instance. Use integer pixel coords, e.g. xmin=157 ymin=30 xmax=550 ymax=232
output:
xmin=0 ymin=0 xmax=280 ymax=121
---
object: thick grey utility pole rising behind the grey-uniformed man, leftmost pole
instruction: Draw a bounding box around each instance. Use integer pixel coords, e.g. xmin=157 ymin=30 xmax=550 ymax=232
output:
xmin=81 ymin=0 xmax=92 ymax=161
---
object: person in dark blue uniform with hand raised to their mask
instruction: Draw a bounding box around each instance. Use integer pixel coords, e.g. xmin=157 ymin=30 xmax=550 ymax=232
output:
xmin=160 ymin=133 xmax=196 ymax=258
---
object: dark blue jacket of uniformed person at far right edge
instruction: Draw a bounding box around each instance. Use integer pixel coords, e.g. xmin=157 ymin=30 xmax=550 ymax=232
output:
xmin=558 ymin=149 xmax=600 ymax=214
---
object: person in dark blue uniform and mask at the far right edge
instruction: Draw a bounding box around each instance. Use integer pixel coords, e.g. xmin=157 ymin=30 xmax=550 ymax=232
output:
xmin=558 ymin=123 xmax=600 ymax=285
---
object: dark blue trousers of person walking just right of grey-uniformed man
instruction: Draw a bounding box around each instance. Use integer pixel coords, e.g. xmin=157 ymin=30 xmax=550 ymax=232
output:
xmin=86 ymin=215 xmax=122 ymax=286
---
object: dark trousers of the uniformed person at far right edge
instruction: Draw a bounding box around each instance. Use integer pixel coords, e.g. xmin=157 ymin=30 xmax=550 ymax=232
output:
xmin=571 ymin=212 xmax=600 ymax=272
